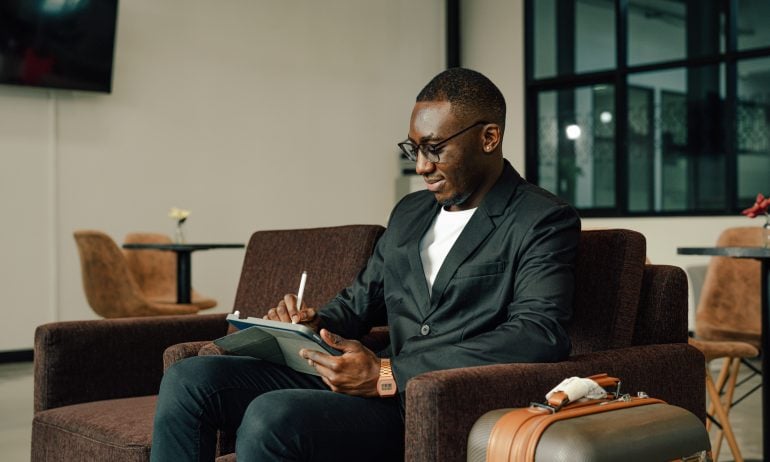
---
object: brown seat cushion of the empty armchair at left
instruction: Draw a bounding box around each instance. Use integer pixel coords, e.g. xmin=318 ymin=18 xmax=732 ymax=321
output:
xmin=32 ymin=396 xmax=157 ymax=462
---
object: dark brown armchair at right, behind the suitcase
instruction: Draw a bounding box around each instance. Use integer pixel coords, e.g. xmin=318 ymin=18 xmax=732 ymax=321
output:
xmin=405 ymin=229 xmax=705 ymax=462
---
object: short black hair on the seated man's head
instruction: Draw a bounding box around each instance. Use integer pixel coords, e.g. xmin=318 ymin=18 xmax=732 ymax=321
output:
xmin=417 ymin=67 xmax=505 ymax=127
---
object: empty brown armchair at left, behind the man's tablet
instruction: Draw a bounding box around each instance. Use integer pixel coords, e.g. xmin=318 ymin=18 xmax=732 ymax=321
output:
xmin=31 ymin=225 xmax=384 ymax=462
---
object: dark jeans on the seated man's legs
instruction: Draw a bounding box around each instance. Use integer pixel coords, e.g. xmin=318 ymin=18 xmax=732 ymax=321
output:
xmin=150 ymin=356 xmax=404 ymax=462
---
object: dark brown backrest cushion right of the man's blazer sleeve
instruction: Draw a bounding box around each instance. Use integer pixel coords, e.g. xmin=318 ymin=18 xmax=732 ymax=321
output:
xmin=568 ymin=229 xmax=647 ymax=354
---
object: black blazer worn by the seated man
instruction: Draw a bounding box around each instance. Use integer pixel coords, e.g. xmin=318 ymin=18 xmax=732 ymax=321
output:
xmin=319 ymin=161 xmax=580 ymax=392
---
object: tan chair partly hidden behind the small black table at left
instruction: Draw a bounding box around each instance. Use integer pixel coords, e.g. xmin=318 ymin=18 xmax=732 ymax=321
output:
xmin=123 ymin=233 xmax=217 ymax=310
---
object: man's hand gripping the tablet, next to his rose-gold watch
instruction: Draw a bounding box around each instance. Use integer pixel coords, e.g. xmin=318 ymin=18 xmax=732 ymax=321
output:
xmin=299 ymin=329 xmax=380 ymax=397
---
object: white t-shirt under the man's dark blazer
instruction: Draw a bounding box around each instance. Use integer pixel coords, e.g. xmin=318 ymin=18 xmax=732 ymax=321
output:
xmin=420 ymin=207 xmax=476 ymax=293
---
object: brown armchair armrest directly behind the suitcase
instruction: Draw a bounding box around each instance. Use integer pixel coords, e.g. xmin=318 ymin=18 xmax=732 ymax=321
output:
xmin=405 ymin=343 xmax=706 ymax=462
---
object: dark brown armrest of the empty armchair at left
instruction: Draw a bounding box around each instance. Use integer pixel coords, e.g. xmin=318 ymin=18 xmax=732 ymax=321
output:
xmin=34 ymin=314 xmax=227 ymax=412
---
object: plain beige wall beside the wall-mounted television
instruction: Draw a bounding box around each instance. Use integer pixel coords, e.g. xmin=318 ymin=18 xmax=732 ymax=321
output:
xmin=0 ymin=0 xmax=445 ymax=351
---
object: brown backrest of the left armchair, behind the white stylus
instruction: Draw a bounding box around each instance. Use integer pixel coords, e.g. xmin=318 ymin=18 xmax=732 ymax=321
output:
xmin=228 ymin=225 xmax=385 ymax=317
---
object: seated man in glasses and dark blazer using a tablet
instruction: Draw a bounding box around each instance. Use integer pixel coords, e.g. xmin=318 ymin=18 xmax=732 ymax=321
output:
xmin=152 ymin=68 xmax=580 ymax=462
